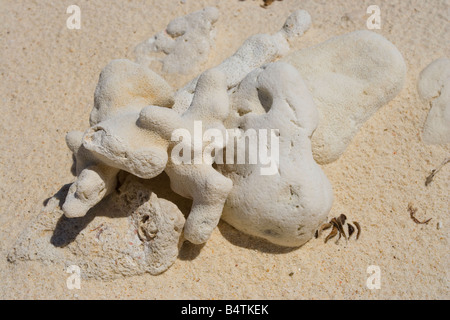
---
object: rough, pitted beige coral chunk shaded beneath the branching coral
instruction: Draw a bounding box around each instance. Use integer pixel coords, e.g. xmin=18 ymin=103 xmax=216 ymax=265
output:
xmin=8 ymin=171 xmax=189 ymax=280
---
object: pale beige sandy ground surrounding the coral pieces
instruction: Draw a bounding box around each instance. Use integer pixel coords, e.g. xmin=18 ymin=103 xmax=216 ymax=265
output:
xmin=0 ymin=0 xmax=450 ymax=299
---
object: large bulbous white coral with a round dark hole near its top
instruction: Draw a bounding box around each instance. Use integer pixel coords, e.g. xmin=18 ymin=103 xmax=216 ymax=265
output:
xmin=218 ymin=62 xmax=333 ymax=247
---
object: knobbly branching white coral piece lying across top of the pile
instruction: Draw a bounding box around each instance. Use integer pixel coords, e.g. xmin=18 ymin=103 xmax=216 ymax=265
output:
xmin=63 ymin=60 xmax=232 ymax=243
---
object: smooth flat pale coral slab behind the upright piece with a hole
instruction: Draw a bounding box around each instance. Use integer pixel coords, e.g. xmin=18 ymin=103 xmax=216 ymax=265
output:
xmin=281 ymin=30 xmax=406 ymax=164
